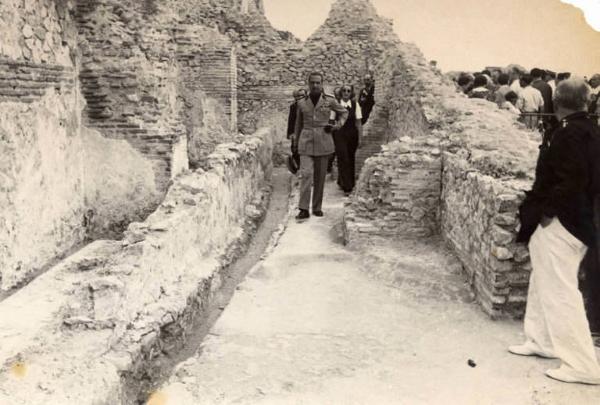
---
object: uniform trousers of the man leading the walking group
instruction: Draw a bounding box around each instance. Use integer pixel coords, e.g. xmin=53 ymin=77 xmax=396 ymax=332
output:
xmin=298 ymin=155 xmax=330 ymax=212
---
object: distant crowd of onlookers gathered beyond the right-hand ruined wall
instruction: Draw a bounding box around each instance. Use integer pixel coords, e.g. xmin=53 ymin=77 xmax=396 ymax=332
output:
xmin=455 ymin=65 xmax=600 ymax=131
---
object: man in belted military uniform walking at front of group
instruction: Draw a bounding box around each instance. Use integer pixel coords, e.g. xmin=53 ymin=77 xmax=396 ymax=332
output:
xmin=293 ymin=72 xmax=348 ymax=221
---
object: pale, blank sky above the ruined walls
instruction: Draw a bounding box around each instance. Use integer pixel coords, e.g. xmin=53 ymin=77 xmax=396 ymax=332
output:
xmin=264 ymin=0 xmax=600 ymax=76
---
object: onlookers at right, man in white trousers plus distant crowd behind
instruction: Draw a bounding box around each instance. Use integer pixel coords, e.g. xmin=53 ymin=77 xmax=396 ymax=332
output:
xmin=457 ymin=68 xmax=600 ymax=385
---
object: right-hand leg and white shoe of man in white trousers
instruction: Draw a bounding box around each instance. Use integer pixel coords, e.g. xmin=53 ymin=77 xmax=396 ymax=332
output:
xmin=532 ymin=218 xmax=600 ymax=384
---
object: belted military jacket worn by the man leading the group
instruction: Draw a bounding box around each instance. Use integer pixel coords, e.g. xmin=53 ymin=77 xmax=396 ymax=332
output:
xmin=294 ymin=93 xmax=348 ymax=156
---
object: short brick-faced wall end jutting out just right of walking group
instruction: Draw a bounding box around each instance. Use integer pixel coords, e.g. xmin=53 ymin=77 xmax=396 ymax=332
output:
xmin=344 ymin=137 xmax=441 ymax=243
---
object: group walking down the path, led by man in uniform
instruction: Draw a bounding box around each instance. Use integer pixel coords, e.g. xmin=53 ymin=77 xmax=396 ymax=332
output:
xmin=287 ymin=72 xmax=375 ymax=221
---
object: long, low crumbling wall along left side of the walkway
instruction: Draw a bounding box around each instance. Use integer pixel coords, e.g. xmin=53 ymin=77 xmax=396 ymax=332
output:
xmin=0 ymin=129 xmax=274 ymax=405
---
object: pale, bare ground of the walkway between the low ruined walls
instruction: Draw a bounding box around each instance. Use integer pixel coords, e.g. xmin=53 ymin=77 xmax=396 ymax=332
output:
xmin=156 ymin=181 xmax=600 ymax=405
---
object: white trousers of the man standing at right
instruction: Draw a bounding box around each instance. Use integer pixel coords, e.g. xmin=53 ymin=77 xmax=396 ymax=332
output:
xmin=525 ymin=218 xmax=600 ymax=379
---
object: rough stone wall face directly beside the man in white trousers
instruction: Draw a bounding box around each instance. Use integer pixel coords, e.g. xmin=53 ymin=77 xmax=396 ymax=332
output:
xmin=441 ymin=153 xmax=530 ymax=318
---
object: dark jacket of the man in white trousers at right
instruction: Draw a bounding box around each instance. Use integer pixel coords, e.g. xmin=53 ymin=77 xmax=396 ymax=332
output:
xmin=517 ymin=112 xmax=600 ymax=246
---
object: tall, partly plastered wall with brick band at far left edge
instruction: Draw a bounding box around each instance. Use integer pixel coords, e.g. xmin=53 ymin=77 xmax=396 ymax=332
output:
xmin=0 ymin=0 xmax=85 ymax=289
